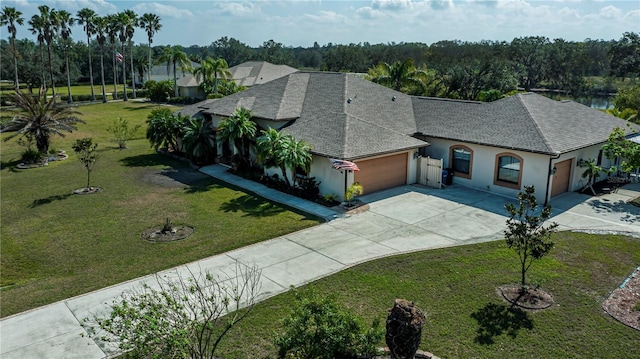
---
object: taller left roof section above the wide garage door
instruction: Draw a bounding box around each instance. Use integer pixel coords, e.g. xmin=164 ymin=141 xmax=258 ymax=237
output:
xmin=205 ymin=72 xmax=428 ymax=159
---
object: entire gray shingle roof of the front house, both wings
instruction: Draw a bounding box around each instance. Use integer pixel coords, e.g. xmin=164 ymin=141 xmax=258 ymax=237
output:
xmin=190 ymin=72 xmax=626 ymax=159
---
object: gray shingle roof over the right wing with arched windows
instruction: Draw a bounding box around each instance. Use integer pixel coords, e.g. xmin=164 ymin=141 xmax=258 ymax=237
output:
xmin=413 ymin=93 xmax=626 ymax=155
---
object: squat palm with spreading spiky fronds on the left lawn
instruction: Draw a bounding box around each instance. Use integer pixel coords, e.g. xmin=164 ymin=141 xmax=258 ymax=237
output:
xmin=2 ymin=91 xmax=85 ymax=153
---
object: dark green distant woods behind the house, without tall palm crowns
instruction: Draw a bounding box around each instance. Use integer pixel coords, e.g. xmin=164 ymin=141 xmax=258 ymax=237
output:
xmin=0 ymin=25 xmax=640 ymax=100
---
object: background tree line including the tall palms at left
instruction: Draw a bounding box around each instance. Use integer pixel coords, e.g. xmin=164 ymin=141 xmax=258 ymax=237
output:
xmin=0 ymin=5 xmax=640 ymax=100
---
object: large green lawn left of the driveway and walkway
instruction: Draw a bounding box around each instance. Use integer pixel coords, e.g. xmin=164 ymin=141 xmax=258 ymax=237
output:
xmin=0 ymin=102 xmax=319 ymax=316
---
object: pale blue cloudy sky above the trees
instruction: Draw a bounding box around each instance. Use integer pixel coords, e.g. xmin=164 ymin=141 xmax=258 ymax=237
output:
xmin=5 ymin=0 xmax=640 ymax=47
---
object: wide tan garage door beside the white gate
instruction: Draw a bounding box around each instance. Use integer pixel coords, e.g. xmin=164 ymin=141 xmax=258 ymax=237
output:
xmin=355 ymin=153 xmax=407 ymax=193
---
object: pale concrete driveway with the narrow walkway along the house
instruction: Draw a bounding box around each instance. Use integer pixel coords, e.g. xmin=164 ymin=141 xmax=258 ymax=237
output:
xmin=0 ymin=170 xmax=640 ymax=359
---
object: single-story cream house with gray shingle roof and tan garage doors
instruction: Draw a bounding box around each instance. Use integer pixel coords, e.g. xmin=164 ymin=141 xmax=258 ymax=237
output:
xmin=181 ymin=72 xmax=626 ymax=202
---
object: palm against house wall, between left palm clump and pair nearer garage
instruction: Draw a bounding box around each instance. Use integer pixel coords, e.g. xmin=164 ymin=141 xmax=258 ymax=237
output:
xmin=218 ymin=107 xmax=256 ymax=168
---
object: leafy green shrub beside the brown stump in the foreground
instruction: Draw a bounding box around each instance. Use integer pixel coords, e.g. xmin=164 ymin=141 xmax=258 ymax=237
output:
xmin=274 ymin=290 xmax=384 ymax=359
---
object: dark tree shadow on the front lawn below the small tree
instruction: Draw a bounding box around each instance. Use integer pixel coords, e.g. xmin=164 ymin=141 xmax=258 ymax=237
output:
xmin=471 ymin=303 xmax=533 ymax=345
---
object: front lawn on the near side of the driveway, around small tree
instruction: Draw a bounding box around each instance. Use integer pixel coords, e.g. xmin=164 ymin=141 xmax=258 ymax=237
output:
xmin=217 ymin=233 xmax=640 ymax=359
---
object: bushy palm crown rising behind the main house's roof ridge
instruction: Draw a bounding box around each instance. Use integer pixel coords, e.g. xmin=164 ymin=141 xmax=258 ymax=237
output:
xmin=367 ymin=59 xmax=427 ymax=92
